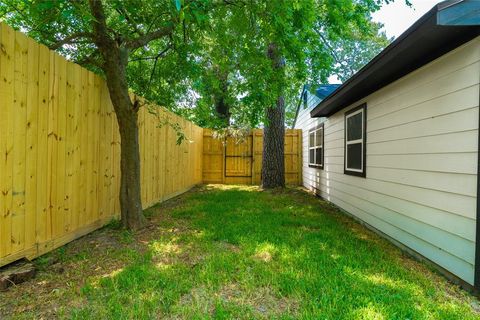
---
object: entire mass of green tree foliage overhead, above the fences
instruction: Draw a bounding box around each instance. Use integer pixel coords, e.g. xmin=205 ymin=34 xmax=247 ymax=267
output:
xmin=0 ymin=0 xmax=390 ymax=128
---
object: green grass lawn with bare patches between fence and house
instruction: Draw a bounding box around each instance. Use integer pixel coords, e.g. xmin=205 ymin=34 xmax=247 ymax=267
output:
xmin=0 ymin=186 xmax=479 ymax=319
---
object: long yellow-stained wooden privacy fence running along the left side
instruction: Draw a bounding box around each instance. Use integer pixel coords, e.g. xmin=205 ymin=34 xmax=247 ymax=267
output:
xmin=0 ymin=24 xmax=203 ymax=266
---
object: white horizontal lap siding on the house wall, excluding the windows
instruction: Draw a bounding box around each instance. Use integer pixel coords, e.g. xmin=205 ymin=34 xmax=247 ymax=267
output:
xmin=296 ymin=38 xmax=480 ymax=284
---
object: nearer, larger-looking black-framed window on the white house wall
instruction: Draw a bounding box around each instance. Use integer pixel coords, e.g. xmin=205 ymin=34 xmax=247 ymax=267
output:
xmin=344 ymin=104 xmax=367 ymax=177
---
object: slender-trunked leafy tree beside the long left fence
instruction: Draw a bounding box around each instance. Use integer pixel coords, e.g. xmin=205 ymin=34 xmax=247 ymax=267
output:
xmin=0 ymin=0 xmax=207 ymax=229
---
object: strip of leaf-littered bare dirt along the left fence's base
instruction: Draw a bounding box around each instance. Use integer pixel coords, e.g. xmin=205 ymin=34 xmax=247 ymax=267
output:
xmin=0 ymin=189 xmax=195 ymax=320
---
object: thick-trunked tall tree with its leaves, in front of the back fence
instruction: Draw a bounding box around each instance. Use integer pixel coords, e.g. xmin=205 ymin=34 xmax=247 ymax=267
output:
xmin=216 ymin=0 xmax=389 ymax=188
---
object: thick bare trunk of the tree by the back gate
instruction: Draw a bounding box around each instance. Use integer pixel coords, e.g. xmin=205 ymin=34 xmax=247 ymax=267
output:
xmin=262 ymin=44 xmax=285 ymax=189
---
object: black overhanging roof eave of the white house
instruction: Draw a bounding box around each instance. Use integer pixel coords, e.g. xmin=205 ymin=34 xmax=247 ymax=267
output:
xmin=310 ymin=0 xmax=480 ymax=117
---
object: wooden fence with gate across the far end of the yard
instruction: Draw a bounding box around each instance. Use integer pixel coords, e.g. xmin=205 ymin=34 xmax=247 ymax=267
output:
xmin=203 ymin=129 xmax=302 ymax=185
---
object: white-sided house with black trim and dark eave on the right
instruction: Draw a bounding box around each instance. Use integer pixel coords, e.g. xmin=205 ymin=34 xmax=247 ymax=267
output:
xmin=294 ymin=0 xmax=480 ymax=289
